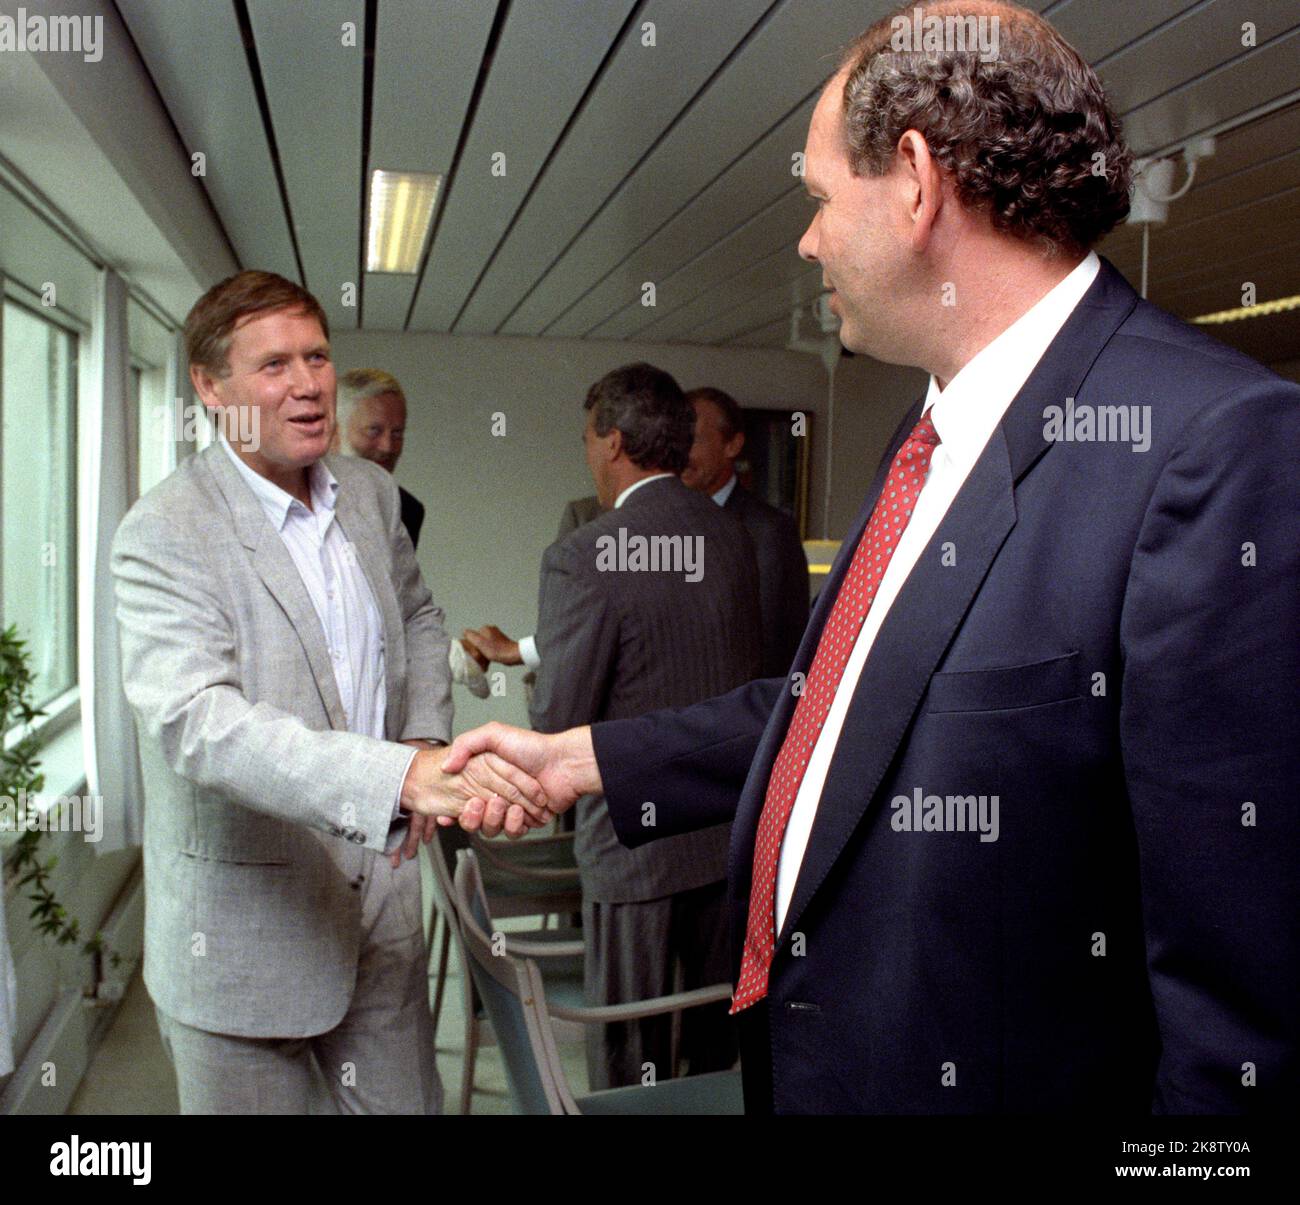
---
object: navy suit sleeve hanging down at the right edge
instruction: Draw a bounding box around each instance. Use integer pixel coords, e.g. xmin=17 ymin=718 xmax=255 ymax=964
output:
xmin=1121 ymin=381 xmax=1300 ymax=1113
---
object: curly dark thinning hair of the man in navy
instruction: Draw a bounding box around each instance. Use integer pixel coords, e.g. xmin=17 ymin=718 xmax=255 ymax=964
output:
xmin=841 ymin=0 xmax=1134 ymax=255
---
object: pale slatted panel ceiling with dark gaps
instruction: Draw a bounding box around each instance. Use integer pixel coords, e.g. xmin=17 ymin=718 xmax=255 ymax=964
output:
xmin=117 ymin=0 xmax=1300 ymax=361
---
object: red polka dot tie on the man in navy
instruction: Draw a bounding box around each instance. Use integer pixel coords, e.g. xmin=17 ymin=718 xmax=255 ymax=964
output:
xmin=732 ymin=412 xmax=939 ymax=1013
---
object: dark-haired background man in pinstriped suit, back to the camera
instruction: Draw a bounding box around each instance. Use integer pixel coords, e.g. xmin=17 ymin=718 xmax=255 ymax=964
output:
xmin=529 ymin=364 xmax=759 ymax=1087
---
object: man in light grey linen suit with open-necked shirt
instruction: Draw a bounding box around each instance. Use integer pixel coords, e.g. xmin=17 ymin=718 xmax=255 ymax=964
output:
xmin=113 ymin=272 xmax=542 ymax=1113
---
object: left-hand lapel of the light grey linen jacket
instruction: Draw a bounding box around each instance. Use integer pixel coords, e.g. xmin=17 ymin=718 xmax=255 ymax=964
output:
xmin=200 ymin=443 xmax=347 ymax=729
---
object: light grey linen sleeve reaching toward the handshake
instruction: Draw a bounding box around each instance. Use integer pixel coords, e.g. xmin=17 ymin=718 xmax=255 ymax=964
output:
xmin=112 ymin=516 xmax=412 ymax=851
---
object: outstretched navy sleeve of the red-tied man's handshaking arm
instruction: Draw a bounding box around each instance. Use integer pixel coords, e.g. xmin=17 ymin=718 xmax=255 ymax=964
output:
xmin=592 ymin=677 xmax=787 ymax=848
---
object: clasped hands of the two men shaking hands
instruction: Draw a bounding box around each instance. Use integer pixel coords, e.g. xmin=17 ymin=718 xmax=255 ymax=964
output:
xmin=391 ymin=723 xmax=602 ymax=866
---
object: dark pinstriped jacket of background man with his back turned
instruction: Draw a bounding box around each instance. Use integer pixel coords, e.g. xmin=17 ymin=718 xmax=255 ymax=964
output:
xmin=529 ymin=477 xmax=761 ymax=903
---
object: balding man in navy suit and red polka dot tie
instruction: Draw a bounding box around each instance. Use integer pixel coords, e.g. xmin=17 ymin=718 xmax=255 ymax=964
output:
xmin=449 ymin=4 xmax=1300 ymax=1113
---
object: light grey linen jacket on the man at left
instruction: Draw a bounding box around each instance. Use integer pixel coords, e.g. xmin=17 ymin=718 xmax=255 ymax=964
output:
xmin=112 ymin=445 xmax=451 ymax=1037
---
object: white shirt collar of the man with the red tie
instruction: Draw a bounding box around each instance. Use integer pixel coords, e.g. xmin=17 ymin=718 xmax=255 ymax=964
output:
xmin=922 ymin=251 xmax=1101 ymax=467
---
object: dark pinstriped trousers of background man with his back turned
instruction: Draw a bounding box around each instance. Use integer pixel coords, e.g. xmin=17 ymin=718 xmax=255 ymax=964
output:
xmin=582 ymin=883 xmax=738 ymax=1091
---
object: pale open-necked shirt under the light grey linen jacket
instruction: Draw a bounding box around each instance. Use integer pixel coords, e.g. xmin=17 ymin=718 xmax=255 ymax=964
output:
xmin=220 ymin=435 xmax=416 ymax=819
